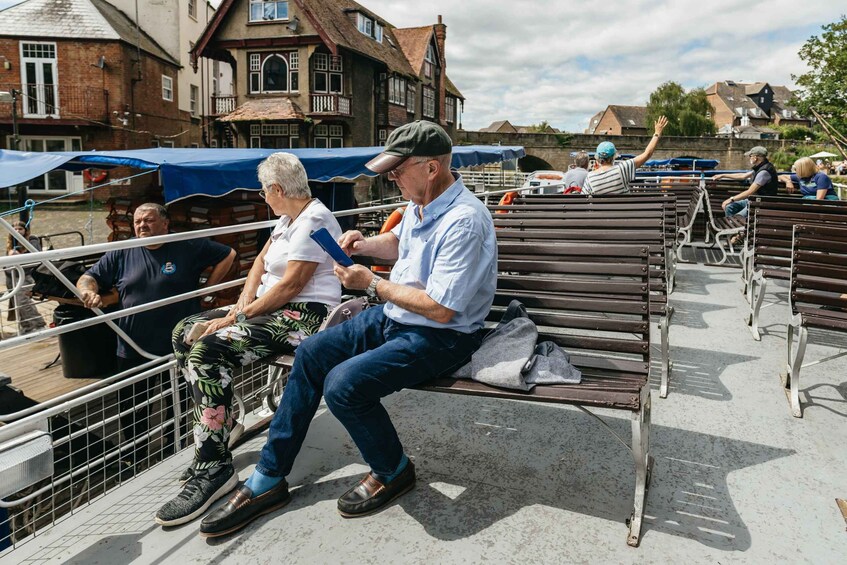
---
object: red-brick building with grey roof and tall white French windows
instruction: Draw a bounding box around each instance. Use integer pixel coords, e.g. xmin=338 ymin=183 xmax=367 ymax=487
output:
xmin=0 ymin=0 xmax=183 ymax=195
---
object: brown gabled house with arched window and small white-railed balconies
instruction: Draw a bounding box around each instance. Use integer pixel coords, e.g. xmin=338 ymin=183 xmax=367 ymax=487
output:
xmin=192 ymin=0 xmax=464 ymax=148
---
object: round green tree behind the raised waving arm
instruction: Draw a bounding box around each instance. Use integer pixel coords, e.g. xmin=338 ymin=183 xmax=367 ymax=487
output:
xmin=647 ymin=82 xmax=715 ymax=137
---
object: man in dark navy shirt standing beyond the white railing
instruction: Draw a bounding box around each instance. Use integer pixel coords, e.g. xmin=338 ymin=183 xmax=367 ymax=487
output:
xmin=76 ymin=203 xmax=235 ymax=463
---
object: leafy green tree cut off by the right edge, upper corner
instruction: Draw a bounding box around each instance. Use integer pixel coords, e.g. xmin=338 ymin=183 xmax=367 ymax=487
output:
xmin=791 ymin=15 xmax=847 ymax=133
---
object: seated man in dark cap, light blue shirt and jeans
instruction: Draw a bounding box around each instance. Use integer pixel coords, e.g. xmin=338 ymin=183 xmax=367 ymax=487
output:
xmin=200 ymin=121 xmax=497 ymax=537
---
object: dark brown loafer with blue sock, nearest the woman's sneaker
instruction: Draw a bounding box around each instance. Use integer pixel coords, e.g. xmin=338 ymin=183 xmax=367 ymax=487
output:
xmin=200 ymin=479 xmax=291 ymax=538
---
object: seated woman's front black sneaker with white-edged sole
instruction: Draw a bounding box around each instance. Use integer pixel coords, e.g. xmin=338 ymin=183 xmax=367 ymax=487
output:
xmin=156 ymin=464 xmax=238 ymax=526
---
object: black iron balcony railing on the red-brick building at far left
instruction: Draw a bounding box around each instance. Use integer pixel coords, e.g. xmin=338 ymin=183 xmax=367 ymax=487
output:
xmin=0 ymin=83 xmax=109 ymax=121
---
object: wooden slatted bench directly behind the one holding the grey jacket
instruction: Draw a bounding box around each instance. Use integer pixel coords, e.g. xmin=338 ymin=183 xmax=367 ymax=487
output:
xmin=489 ymin=203 xmax=674 ymax=398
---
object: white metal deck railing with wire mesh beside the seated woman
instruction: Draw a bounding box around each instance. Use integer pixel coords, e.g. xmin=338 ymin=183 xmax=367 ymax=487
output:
xmin=0 ymin=184 xmax=524 ymax=547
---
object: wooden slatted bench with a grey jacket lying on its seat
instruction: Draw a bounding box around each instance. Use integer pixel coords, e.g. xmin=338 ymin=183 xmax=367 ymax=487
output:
xmin=418 ymin=239 xmax=653 ymax=546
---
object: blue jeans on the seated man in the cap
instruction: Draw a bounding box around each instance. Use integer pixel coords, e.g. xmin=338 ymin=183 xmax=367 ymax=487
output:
xmin=256 ymin=306 xmax=482 ymax=477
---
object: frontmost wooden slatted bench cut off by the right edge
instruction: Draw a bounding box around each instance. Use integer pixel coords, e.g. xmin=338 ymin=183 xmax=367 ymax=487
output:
xmin=782 ymin=224 xmax=847 ymax=418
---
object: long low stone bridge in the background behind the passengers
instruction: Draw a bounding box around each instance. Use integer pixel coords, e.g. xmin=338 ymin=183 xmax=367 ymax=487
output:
xmin=454 ymin=131 xmax=816 ymax=172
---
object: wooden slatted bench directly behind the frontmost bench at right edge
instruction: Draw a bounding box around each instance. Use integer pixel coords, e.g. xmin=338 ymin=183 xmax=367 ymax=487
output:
xmin=745 ymin=197 xmax=847 ymax=341
